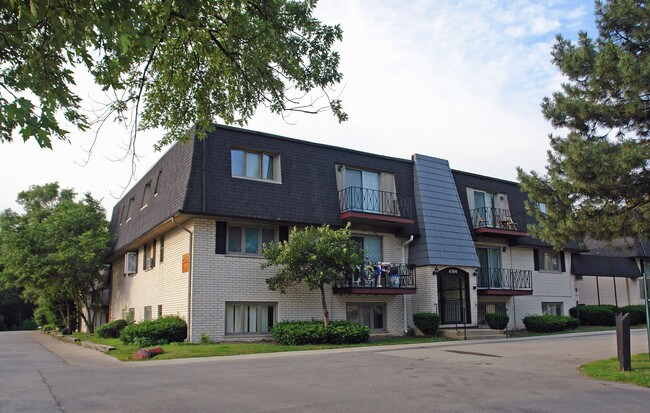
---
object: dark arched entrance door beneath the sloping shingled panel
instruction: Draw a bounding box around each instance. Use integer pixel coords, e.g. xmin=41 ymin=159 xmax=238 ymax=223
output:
xmin=438 ymin=268 xmax=472 ymax=324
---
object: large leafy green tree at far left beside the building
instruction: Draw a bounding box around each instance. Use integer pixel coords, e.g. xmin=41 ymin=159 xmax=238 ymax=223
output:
xmin=0 ymin=183 xmax=110 ymax=332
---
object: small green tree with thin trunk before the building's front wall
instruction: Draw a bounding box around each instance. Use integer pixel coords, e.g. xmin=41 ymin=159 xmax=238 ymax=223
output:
xmin=262 ymin=225 xmax=363 ymax=327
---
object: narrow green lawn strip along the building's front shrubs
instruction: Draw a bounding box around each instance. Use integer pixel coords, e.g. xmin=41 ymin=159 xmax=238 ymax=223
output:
xmin=72 ymin=333 xmax=450 ymax=361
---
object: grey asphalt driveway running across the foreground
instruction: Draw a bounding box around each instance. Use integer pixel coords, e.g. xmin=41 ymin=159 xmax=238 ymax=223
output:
xmin=0 ymin=331 xmax=650 ymax=413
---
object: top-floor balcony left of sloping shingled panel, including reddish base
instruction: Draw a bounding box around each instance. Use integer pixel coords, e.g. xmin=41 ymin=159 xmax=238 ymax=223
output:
xmin=339 ymin=186 xmax=415 ymax=226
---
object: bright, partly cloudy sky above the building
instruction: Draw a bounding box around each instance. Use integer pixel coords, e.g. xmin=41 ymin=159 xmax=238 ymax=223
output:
xmin=0 ymin=0 xmax=596 ymax=217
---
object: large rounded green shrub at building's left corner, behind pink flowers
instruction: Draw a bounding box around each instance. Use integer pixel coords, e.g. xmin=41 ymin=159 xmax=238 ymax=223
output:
xmin=120 ymin=316 xmax=187 ymax=347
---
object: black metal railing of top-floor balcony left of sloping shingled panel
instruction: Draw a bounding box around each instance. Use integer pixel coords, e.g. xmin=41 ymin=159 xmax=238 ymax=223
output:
xmin=339 ymin=186 xmax=414 ymax=219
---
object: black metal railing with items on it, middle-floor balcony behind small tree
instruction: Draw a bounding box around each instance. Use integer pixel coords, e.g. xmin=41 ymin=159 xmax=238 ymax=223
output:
xmin=335 ymin=262 xmax=416 ymax=289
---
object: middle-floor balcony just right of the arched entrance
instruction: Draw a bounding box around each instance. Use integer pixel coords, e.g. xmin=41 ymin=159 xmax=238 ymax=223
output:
xmin=476 ymin=268 xmax=533 ymax=295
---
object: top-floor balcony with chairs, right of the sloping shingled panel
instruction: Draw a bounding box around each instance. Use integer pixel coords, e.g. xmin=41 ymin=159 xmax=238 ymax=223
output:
xmin=470 ymin=207 xmax=528 ymax=237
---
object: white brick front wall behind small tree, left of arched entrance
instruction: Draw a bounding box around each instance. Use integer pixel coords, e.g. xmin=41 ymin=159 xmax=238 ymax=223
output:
xmin=191 ymin=219 xmax=410 ymax=341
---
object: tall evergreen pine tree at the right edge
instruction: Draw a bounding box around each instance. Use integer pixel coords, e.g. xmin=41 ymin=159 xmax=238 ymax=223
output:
xmin=518 ymin=0 xmax=650 ymax=248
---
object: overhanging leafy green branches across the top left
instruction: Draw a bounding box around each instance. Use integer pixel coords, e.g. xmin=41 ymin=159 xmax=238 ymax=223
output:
xmin=0 ymin=0 xmax=347 ymax=148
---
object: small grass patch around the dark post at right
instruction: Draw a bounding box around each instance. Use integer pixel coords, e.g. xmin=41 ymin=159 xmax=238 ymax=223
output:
xmin=580 ymin=353 xmax=650 ymax=387
